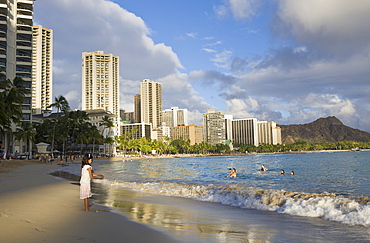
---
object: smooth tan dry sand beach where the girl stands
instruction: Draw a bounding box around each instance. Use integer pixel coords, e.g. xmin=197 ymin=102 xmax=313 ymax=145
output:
xmin=0 ymin=160 xmax=177 ymax=243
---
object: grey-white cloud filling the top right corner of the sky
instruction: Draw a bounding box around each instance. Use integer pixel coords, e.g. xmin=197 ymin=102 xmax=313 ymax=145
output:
xmin=274 ymin=0 xmax=370 ymax=55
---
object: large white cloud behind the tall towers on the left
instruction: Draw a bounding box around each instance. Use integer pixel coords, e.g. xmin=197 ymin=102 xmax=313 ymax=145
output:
xmin=34 ymin=0 xmax=183 ymax=108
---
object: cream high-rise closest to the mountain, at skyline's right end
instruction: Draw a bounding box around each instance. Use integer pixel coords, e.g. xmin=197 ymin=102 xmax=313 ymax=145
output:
xmin=258 ymin=121 xmax=281 ymax=145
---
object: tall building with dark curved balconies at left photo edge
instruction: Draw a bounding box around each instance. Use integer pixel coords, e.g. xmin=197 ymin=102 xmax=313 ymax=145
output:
xmin=0 ymin=0 xmax=34 ymax=121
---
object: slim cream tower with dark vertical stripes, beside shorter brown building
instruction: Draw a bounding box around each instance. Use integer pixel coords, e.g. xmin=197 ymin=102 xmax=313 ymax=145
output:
xmin=140 ymin=79 xmax=162 ymax=129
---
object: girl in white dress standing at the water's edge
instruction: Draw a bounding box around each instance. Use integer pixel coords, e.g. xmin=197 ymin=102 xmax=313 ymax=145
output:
xmin=80 ymin=154 xmax=104 ymax=211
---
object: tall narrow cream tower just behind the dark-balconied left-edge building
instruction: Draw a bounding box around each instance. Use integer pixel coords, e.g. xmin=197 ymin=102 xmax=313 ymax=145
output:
xmin=32 ymin=25 xmax=53 ymax=114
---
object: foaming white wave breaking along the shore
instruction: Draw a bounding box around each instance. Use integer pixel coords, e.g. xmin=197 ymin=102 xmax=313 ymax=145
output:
xmin=105 ymin=180 xmax=370 ymax=227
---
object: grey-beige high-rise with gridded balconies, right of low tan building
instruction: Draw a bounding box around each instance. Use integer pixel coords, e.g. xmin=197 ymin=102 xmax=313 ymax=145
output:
xmin=203 ymin=109 xmax=226 ymax=145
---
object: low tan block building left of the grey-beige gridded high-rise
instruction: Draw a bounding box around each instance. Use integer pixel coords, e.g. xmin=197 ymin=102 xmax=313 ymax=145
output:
xmin=171 ymin=124 xmax=203 ymax=145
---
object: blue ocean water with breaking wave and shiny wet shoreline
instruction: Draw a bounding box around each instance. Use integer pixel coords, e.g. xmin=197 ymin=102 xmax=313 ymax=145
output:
xmin=54 ymin=151 xmax=370 ymax=242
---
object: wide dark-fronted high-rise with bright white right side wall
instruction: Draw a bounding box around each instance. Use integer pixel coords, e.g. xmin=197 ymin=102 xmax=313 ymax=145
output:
xmin=232 ymin=118 xmax=258 ymax=147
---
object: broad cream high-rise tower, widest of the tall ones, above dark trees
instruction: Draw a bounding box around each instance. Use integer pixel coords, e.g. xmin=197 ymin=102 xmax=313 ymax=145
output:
xmin=82 ymin=51 xmax=120 ymax=135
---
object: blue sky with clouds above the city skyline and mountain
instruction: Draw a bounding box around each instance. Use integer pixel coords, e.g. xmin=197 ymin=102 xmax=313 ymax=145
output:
xmin=34 ymin=0 xmax=370 ymax=132
